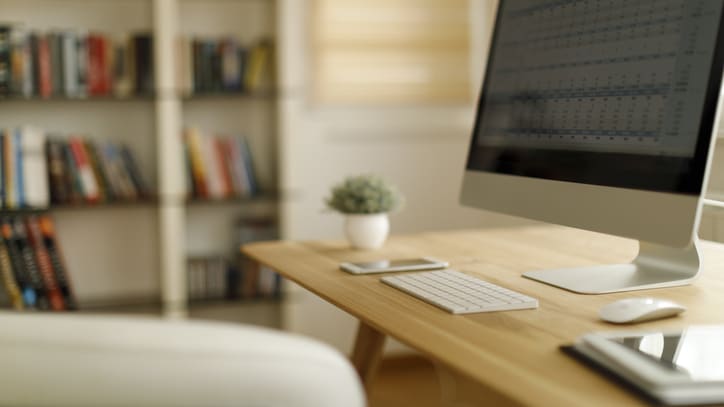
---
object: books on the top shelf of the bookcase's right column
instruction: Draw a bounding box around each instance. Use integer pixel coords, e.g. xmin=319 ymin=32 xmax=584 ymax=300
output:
xmin=177 ymin=37 xmax=272 ymax=95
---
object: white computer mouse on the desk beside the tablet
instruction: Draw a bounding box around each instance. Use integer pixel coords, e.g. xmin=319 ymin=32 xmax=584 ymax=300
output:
xmin=598 ymin=298 xmax=686 ymax=324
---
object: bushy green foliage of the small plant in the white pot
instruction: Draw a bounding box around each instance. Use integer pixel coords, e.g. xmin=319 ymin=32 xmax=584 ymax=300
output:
xmin=325 ymin=175 xmax=402 ymax=214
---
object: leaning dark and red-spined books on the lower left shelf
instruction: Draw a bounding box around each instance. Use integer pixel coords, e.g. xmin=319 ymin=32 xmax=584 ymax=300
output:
xmin=0 ymin=214 xmax=76 ymax=311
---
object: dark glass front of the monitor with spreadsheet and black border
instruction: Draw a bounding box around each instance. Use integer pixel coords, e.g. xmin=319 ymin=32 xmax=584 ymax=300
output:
xmin=467 ymin=0 xmax=724 ymax=194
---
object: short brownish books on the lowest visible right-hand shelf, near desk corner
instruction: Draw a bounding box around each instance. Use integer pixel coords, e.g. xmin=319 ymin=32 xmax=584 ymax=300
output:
xmin=186 ymin=256 xmax=281 ymax=300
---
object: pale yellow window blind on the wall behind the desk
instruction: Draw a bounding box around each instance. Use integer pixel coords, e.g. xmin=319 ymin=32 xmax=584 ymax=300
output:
xmin=310 ymin=0 xmax=472 ymax=104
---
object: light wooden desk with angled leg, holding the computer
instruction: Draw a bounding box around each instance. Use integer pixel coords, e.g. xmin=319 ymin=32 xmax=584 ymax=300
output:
xmin=244 ymin=226 xmax=724 ymax=406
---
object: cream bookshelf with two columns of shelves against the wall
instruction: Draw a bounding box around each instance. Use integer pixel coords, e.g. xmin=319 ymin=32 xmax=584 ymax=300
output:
xmin=0 ymin=0 xmax=279 ymax=325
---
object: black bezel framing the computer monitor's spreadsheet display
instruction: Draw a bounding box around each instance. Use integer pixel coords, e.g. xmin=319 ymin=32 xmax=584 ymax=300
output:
xmin=466 ymin=0 xmax=724 ymax=195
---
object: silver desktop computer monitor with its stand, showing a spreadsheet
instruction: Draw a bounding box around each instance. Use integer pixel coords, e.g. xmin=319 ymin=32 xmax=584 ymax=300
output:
xmin=461 ymin=0 xmax=724 ymax=293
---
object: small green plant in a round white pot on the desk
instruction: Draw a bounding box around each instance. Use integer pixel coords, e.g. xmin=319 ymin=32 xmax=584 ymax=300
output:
xmin=326 ymin=175 xmax=402 ymax=249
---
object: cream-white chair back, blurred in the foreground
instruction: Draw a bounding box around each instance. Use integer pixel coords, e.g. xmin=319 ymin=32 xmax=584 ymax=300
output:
xmin=0 ymin=312 xmax=365 ymax=407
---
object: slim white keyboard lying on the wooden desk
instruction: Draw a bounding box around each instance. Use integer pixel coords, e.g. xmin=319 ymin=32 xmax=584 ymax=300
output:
xmin=381 ymin=269 xmax=538 ymax=314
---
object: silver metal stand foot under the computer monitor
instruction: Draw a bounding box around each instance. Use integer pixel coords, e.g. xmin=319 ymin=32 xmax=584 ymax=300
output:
xmin=523 ymin=238 xmax=700 ymax=294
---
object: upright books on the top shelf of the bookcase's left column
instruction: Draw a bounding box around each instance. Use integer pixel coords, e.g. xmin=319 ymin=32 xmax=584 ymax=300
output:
xmin=0 ymin=25 xmax=153 ymax=98
